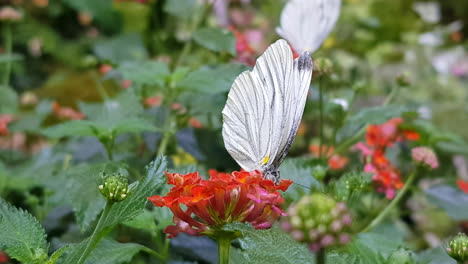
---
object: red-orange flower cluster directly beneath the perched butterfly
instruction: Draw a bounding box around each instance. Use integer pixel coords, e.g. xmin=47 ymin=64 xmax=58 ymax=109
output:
xmin=148 ymin=170 xmax=292 ymax=237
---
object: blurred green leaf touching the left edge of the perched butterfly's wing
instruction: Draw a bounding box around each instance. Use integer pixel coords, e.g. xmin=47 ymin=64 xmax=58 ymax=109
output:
xmin=178 ymin=64 xmax=247 ymax=94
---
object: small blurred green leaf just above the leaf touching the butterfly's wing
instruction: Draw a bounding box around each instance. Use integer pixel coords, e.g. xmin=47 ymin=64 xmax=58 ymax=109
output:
xmin=193 ymin=28 xmax=236 ymax=56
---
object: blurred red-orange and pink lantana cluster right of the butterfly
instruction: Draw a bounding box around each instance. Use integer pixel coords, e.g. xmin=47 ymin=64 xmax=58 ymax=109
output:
xmin=356 ymin=117 xmax=419 ymax=200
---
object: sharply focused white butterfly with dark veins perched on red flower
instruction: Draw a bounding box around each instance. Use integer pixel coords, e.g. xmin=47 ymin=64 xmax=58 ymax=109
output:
xmin=223 ymin=40 xmax=312 ymax=183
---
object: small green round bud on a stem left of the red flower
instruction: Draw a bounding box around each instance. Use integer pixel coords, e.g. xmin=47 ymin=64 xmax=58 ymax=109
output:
xmin=99 ymin=173 xmax=129 ymax=202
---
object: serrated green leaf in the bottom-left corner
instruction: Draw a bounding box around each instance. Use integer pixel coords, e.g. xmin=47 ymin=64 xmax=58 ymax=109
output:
xmin=0 ymin=198 xmax=48 ymax=264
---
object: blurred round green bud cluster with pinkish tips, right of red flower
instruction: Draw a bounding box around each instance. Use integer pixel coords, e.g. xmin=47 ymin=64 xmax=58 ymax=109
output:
xmin=281 ymin=193 xmax=352 ymax=252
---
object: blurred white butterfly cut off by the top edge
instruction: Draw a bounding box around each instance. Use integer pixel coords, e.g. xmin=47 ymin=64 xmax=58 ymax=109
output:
xmin=276 ymin=0 xmax=341 ymax=53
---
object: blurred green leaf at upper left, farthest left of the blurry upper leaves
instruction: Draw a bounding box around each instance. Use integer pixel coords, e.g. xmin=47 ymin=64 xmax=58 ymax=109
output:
xmin=94 ymin=34 xmax=148 ymax=64
